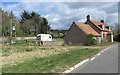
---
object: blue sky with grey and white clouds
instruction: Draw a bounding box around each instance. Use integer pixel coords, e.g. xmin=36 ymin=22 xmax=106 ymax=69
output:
xmin=1 ymin=0 xmax=118 ymax=30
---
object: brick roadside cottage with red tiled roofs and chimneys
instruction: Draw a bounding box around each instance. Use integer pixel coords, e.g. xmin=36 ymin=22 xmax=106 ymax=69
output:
xmin=64 ymin=15 xmax=113 ymax=44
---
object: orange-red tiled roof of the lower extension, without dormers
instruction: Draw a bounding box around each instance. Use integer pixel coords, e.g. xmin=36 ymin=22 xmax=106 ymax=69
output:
xmin=76 ymin=22 xmax=100 ymax=36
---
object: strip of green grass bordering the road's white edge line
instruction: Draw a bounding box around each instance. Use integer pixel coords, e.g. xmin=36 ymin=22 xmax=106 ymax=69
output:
xmin=2 ymin=48 xmax=100 ymax=73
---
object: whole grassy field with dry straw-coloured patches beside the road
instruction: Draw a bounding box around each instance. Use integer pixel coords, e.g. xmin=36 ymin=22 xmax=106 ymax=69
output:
xmin=2 ymin=39 xmax=106 ymax=73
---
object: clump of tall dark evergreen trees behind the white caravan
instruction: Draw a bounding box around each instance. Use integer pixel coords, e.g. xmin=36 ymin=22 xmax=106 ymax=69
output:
xmin=20 ymin=11 xmax=50 ymax=35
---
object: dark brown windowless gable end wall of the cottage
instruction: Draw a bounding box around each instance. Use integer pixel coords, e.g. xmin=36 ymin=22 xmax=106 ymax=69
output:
xmin=64 ymin=24 xmax=88 ymax=44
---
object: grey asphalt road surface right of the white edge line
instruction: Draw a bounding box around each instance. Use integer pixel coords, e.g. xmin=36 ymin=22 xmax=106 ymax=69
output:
xmin=70 ymin=44 xmax=118 ymax=73
